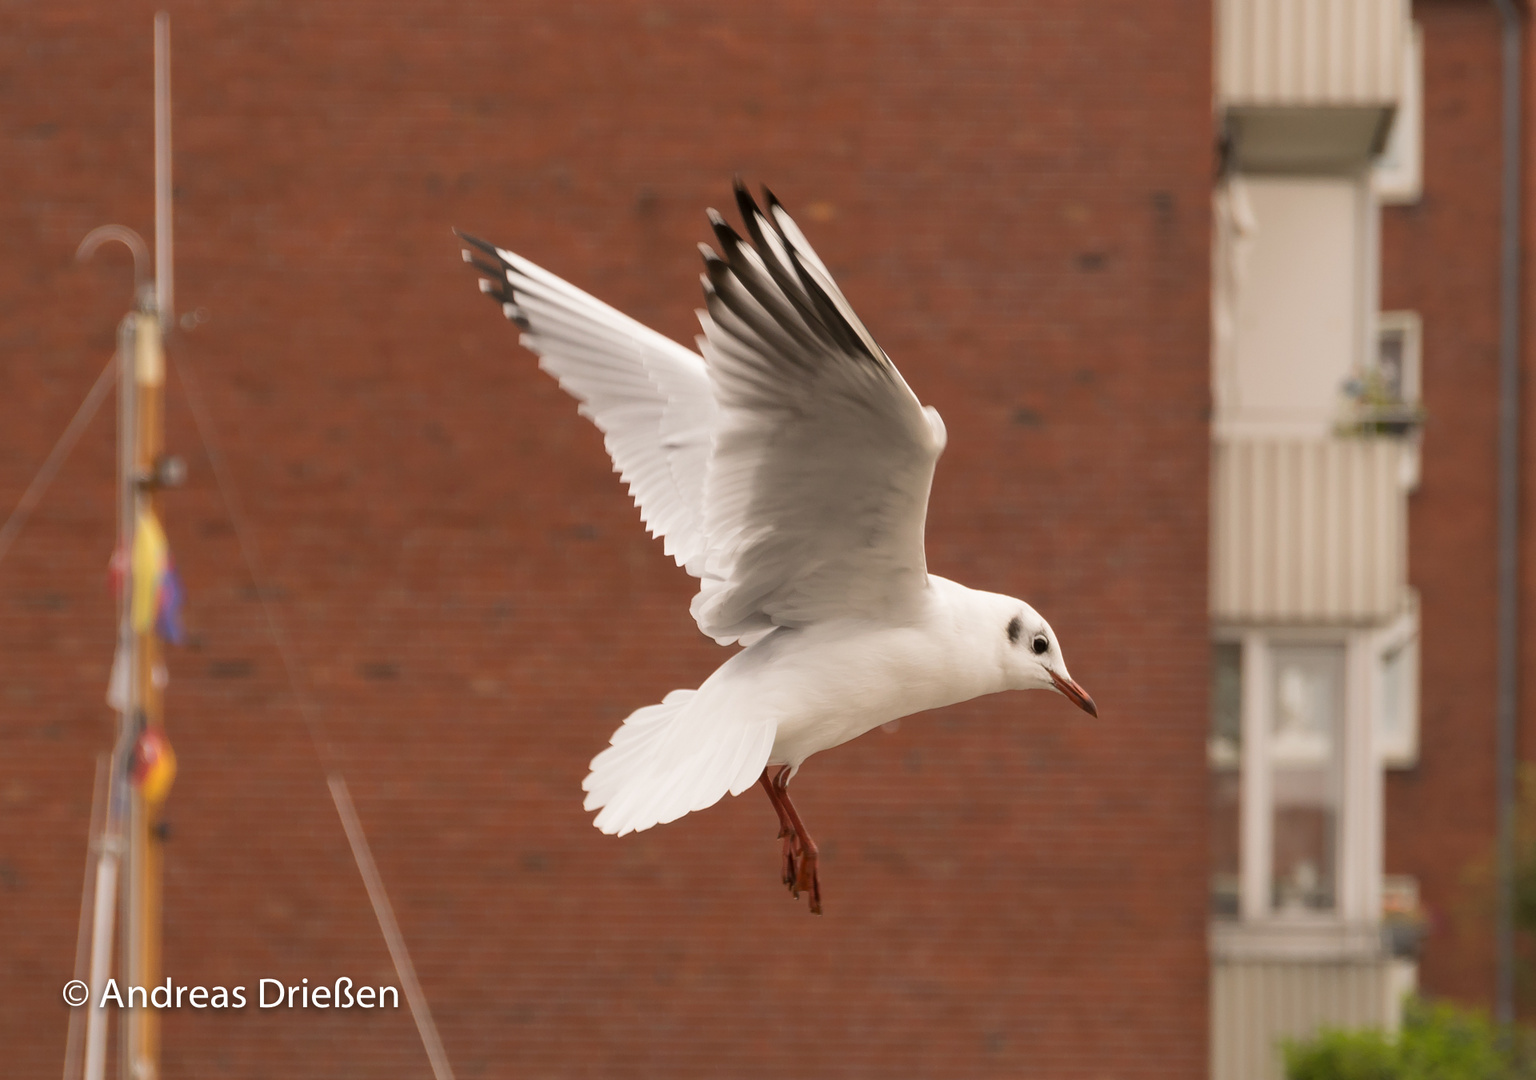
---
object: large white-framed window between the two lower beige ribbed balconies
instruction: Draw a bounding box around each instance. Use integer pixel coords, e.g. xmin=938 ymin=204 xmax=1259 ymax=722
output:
xmin=1206 ymin=626 xmax=1418 ymax=934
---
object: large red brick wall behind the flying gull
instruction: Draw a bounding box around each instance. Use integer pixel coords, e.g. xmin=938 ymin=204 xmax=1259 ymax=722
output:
xmin=0 ymin=0 xmax=1210 ymax=1078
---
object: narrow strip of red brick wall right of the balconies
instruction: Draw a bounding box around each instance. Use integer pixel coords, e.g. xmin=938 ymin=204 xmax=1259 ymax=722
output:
xmin=1382 ymin=0 xmax=1536 ymax=1005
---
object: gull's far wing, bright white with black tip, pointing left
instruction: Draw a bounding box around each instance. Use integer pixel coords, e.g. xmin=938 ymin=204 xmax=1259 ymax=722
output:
xmin=459 ymin=234 xmax=717 ymax=576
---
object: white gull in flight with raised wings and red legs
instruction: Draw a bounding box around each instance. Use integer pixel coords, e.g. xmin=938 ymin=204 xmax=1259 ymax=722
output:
xmin=461 ymin=180 xmax=1098 ymax=914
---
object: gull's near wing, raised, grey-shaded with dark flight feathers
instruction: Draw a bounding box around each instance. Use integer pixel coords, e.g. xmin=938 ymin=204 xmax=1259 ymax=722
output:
xmin=693 ymin=183 xmax=945 ymax=644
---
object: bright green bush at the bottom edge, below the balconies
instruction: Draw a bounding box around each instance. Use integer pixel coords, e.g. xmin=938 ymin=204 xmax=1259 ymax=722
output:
xmin=1284 ymin=1002 xmax=1536 ymax=1080
